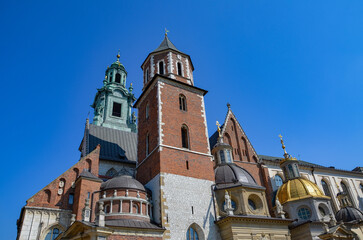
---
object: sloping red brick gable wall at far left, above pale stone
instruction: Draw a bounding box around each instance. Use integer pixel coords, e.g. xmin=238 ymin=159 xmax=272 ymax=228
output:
xmin=26 ymin=146 xmax=100 ymax=210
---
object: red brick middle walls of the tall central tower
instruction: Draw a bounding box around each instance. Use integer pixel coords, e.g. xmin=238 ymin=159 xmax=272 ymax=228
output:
xmin=137 ymin=78 xmax=214 ymax=184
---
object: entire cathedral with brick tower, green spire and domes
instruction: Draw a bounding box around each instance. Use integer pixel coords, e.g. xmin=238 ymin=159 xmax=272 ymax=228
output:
xmin=17 ymin=34 xmax=363 ymax=240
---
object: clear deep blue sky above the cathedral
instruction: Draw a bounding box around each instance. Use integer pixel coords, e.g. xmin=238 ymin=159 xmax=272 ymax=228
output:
xmin=0 ymin=0 xmax=363 ymax=239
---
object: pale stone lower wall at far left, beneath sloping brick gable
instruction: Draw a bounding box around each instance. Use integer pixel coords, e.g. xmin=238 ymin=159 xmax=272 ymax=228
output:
xmin=19 ymin=207 xmax=72 ymax=240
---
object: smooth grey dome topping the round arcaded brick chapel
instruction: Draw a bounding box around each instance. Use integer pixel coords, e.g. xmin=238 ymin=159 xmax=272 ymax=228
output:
xmin=101 ymin=175 xmax=146 ymax=192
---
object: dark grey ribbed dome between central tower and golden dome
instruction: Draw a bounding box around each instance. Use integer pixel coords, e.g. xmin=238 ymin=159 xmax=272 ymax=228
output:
xmin=214 ymin=164 xmax=263 ymax=189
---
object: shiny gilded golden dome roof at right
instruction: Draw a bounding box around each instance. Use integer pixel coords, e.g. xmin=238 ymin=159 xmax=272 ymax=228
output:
xmin=277 ymin=178 xmax=330 ymax=204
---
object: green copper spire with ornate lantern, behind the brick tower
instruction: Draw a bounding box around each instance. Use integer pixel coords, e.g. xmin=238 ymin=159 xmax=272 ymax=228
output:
xmin=91 ymin=52 xmax=136 ymax=132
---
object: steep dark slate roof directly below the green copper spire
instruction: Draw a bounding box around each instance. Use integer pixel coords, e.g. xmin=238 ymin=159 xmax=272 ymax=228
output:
xmin=88 ymin=124 xmax=137 ymax=163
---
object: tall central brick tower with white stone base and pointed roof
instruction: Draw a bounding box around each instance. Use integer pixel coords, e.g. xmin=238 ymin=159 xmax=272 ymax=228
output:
xmin=135 ymin=34 xmax=219 ymax=239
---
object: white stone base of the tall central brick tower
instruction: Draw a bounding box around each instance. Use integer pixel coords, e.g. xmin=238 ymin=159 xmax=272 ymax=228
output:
xmin=146 ymin=173 xmax=221 ymax=240
